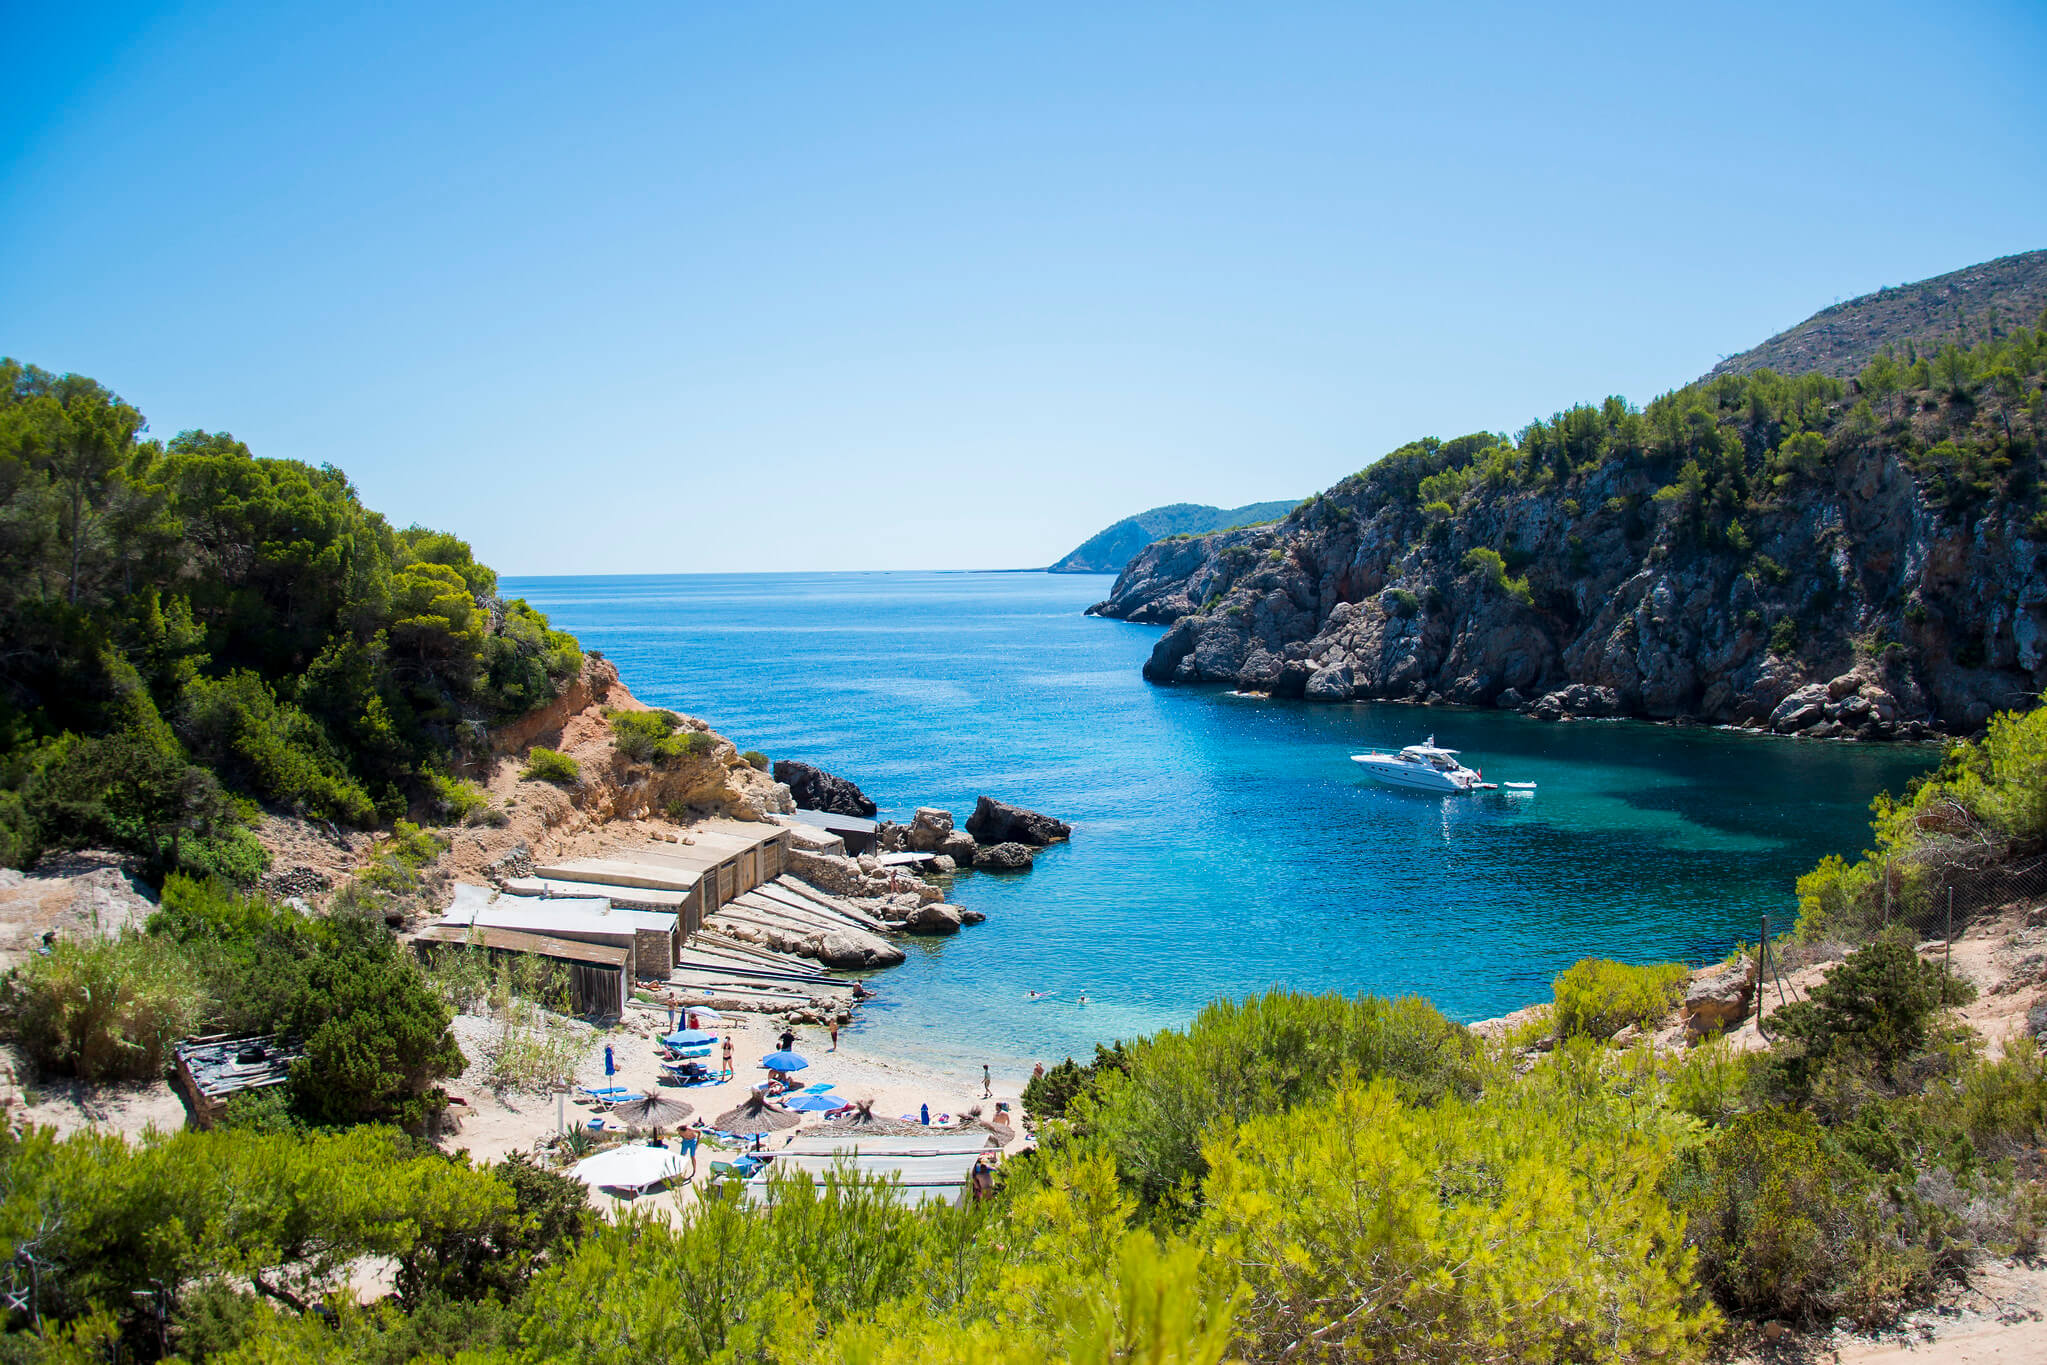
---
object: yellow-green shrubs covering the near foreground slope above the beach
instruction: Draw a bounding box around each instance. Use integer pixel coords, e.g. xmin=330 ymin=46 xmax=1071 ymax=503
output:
xmin=15 ymin=712 xmax=2047 ymax=1365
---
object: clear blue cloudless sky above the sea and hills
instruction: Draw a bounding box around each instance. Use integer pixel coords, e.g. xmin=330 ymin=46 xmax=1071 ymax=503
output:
xmin=0 ymin=0 xmax=2047 ymax=573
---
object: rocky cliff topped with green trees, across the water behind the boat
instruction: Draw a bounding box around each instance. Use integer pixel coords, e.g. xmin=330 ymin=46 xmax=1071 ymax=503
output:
xmin=1089 ymin=329 xmax=2047 ymax=739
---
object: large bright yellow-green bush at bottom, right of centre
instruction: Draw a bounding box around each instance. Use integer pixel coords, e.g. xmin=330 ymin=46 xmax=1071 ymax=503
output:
xmin=1193 ymin=1081 xmax=1717 ymax=1361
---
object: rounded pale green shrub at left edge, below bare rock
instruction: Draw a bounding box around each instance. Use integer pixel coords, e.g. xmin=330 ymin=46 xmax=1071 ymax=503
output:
xmin=0 ymin=931 xmax=203 ymax=1081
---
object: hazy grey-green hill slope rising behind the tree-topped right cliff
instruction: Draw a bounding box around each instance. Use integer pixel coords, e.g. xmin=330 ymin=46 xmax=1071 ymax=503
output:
xmin=1707 ymin=252 xmax=2047 ymax=379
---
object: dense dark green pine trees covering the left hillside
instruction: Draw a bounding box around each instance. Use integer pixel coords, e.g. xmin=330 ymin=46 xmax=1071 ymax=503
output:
xmin=0 ymin=360 xmax=581 ymax=882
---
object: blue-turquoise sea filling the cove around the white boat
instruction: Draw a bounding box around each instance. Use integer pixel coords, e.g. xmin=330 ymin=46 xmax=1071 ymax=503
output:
xmin=504 ymin=573 xmax=1934 ymax=1066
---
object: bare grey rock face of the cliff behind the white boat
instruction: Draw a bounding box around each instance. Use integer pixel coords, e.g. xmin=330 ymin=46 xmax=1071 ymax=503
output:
xmin=1080 ymin=417 xmax=2047 ymax=736
